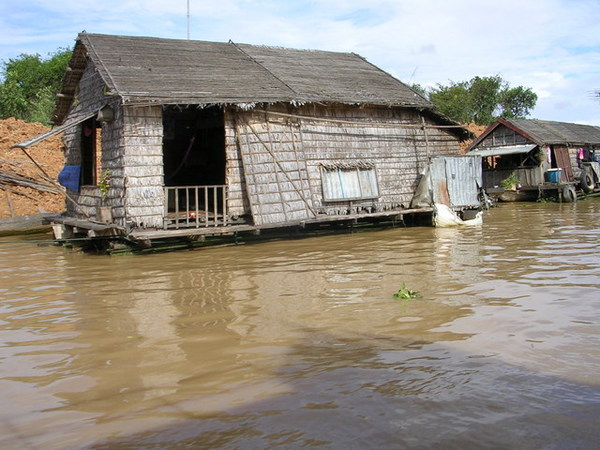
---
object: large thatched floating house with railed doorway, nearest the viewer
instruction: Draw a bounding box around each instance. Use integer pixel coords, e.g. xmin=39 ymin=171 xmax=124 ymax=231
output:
xmin=12 ymin=33 xmax=476 ymax=248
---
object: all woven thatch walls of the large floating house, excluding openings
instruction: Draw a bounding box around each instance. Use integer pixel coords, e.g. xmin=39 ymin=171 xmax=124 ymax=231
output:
xmin=65 ymin=92 xmax=459 ymax=228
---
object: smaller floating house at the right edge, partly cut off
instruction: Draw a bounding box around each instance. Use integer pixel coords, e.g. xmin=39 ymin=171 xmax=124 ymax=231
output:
xmin=468 ymin=119 xmax=600 ymax=201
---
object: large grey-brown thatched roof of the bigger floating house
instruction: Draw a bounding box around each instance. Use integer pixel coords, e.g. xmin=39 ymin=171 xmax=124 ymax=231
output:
xmin=55 ymin=33 xmax=433 ymax=123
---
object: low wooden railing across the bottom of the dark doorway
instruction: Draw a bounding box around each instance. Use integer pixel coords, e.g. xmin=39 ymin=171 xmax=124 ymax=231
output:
xmin=163 ymin=185 xmax=227 ymax=230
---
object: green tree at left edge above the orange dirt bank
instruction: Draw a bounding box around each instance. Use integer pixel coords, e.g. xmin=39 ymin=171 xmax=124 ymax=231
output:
xmin=0 ymin=49 xmax=71 ymax=123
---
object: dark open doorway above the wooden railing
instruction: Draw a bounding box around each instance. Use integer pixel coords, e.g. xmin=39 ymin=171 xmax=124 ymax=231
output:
xmin=163 ymin=106 xmax=225 ymax=186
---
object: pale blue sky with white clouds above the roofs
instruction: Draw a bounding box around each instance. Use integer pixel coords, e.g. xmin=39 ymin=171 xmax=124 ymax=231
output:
xmin=0 ymin=0 xmax=600 ymax=126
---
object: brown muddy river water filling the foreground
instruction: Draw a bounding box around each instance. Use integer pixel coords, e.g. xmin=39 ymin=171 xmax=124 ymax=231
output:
xmin=0 ymin=199 xmax=600 ymax=449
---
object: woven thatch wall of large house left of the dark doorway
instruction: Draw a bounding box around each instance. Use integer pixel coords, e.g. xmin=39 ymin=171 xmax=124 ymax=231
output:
xmin=64 ymin=63 xmax=164 ymax=228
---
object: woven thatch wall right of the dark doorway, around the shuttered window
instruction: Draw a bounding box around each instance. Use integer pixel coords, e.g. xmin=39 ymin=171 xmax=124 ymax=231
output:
xmin=226 ymin=105 xmax=460 ymax=224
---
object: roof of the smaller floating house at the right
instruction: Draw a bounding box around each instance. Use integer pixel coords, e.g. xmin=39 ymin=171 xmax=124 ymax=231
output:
xmin=469 ymin=119 xmax=600 ymax=149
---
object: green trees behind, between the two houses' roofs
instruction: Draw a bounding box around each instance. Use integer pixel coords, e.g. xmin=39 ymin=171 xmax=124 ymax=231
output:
xmin=429 ymin=75 xmax=537 ymax=125
